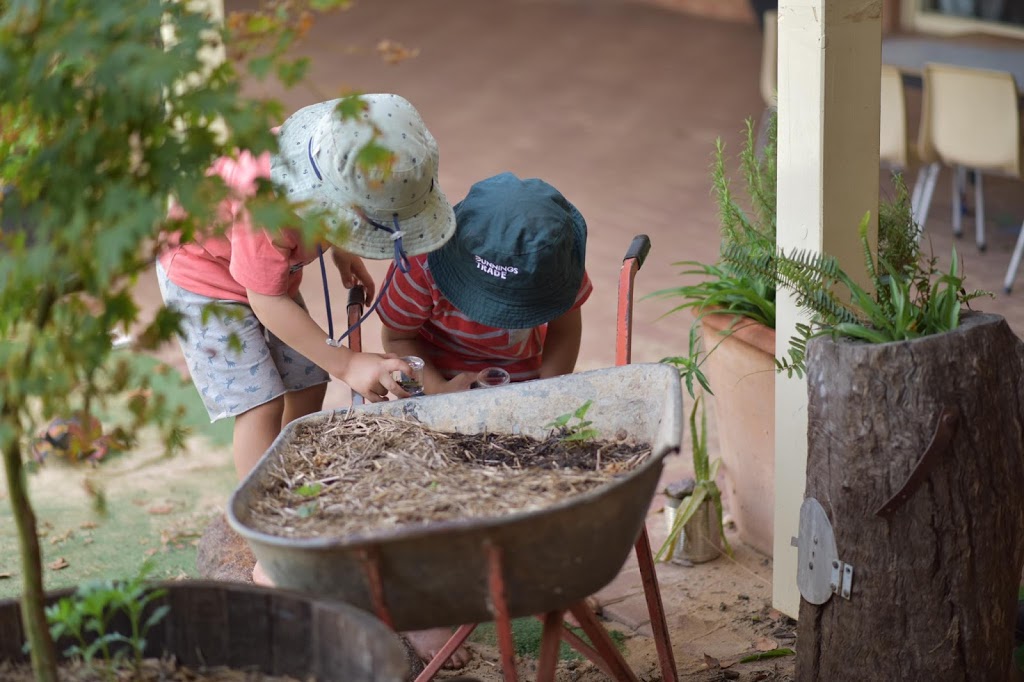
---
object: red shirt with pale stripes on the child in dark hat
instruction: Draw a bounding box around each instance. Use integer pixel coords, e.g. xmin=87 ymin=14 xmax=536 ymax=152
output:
xmin=377 ymin=254 xmax=594 ymax=381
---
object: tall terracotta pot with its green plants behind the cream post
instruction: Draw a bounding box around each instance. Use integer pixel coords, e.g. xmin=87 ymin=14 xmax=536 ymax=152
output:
xmin=650 ymin=111 xmax=916 ymax=556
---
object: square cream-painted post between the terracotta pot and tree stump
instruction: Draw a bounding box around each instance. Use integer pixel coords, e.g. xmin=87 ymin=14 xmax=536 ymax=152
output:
xmin=772 ymin=0 xmax=882 ymax=616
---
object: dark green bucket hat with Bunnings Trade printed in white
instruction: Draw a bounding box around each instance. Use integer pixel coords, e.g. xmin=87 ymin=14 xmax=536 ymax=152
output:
xmin=427 ymin=173 xmax=587 ymax=329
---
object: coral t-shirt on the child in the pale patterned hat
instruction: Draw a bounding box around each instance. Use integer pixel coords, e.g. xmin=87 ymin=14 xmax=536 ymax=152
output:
xmin=160 ymin=152 xmax=316 ymax=303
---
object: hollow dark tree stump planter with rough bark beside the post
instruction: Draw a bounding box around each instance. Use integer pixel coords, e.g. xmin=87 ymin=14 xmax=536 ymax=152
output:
xmin=796 ymin=313 xmax=1024 ymax=682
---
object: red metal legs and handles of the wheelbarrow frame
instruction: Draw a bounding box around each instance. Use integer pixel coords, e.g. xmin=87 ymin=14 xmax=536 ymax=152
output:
xmin=346 ymin=235 xmax=679 ymax=682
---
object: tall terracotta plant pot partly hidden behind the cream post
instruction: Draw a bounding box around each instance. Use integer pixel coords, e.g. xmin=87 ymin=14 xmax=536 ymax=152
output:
xmin=700 ymin=313 xmax=775 ymax=556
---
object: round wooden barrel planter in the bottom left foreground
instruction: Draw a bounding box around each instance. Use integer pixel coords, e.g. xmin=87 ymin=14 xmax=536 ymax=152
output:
xmin=0 ymin=581 xmax=408 ymax=682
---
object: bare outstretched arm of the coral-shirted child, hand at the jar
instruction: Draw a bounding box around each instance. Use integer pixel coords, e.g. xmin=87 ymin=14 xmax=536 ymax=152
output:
xmin=247 ymin=290 xmax=410 ymax=402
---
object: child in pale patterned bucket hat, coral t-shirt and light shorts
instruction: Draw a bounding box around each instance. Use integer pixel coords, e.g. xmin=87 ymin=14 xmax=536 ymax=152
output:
xmin=157 ymin=94 xmax=455 ymax=477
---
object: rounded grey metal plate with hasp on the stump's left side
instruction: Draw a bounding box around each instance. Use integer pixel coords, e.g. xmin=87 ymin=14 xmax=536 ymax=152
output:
xmin=792 ymin=498 xmax=853 ymax=604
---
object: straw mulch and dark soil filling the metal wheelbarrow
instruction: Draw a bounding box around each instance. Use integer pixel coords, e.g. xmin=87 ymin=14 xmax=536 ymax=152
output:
xmin=243 ymin=412 xmax=651 ymax=538
